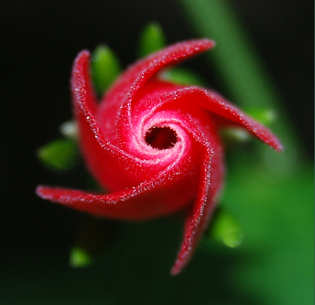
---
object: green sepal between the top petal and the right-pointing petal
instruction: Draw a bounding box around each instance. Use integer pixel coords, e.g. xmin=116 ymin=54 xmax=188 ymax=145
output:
xmin=160 ymin=68 xmax=207 ymax=87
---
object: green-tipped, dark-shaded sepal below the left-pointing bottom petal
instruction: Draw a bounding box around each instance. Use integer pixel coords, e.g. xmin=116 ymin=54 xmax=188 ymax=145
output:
xmin=69 ymin=216 xmax=120 ymax=268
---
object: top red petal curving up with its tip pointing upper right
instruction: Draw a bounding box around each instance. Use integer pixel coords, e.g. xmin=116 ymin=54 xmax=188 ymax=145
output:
xmin=99 ymin=39 xmax=215 ymax=145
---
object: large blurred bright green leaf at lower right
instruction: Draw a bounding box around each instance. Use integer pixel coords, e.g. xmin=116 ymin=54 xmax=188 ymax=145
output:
xmin=224 ymin=156 xmax=314 ymax=305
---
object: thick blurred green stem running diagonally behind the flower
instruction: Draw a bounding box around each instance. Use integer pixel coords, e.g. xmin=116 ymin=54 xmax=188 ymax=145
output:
xmin=179 ymin=0 xmax=299 ymax=168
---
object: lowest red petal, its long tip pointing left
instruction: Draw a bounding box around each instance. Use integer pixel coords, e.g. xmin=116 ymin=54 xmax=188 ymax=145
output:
xmin=36 ymin=160 xmax=195 ymax=220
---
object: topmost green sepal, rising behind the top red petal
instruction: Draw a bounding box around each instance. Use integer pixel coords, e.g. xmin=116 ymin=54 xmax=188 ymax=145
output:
xmin=138 ymin=23 xmax=166 ymax=58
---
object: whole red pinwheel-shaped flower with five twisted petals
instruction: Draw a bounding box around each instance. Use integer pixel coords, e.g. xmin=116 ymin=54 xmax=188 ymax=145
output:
xmin=37 ymin=39 xmax=282 ymax=274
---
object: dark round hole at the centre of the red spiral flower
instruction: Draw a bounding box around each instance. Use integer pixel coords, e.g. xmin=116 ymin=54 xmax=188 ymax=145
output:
xmin=145 ymin=127 xmax=177 ymax=149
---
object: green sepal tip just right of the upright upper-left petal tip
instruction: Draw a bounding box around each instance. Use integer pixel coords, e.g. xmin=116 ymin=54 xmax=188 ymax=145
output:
xmin=91 ymin=45 xmax=121 ymax=96
